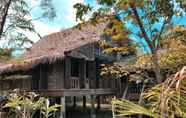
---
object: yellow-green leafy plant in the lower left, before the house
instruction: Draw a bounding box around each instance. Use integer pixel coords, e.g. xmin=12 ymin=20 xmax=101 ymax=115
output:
xmin=4 ymin=90 xmax=44 ymax=118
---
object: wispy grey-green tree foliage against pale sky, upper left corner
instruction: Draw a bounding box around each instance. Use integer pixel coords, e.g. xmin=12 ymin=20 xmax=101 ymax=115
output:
xmin=0 ymin=0 xmax=56 ymax=50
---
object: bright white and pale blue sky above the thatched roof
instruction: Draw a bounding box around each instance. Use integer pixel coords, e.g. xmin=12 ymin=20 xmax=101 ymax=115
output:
xmin=26 ymin=0 xmax=96 ymax=42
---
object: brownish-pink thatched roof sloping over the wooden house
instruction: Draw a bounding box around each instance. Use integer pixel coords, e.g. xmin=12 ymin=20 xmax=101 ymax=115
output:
xmin=0 ymin=22 xmax=106 ymax=73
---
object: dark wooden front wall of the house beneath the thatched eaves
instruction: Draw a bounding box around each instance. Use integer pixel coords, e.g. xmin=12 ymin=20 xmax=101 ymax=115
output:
xmin=32 ymin=56 xmax=107 ymax=90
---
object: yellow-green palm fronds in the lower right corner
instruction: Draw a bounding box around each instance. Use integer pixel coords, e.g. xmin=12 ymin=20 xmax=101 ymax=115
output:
xmin=112 ymin=67 xmax=186 ymax=118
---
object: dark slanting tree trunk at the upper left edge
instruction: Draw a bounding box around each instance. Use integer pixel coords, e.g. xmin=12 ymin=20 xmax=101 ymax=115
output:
xmin=0 ymin=0 xmax=12 ymax=39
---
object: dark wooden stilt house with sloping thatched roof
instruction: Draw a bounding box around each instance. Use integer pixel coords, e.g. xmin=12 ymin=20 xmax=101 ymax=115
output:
xmin=0 ymin=23 xmax=120 ymax=97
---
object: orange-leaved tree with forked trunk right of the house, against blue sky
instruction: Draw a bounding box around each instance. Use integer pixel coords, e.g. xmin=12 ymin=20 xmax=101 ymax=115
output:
xmin=76 ymin=0 xmax=186 ymax=83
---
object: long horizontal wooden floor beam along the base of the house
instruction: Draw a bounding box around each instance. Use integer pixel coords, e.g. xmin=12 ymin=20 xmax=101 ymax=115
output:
xmin=37 ymin=89 xmax=116 ymax=97
